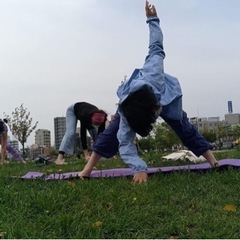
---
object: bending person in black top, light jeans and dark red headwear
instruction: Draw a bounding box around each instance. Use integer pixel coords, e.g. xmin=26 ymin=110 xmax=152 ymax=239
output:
xmin=55 ymin=102 xmax=107 ymax=165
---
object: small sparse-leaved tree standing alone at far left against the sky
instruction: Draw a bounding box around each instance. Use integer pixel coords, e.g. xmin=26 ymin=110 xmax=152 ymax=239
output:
xmin=4 ymin=103 xmax=38 ymax=155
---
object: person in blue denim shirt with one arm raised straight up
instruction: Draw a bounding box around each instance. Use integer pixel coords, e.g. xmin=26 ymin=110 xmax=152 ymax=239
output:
xmin=78 ymin=1 xmax=218 ymax=183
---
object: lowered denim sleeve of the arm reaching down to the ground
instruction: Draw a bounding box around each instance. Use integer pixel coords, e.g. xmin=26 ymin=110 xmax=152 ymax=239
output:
xmin=117 ymin=111 xmax=147 ymax=174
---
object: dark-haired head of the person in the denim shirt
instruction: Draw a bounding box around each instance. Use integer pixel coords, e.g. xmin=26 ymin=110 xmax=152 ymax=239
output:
xmin=121 ymin=88 xmax=160 ymax=137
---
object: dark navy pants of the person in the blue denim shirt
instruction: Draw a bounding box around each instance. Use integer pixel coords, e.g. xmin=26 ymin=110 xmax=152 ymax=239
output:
xmin=93 ymin=111 xmax=212 ymax=158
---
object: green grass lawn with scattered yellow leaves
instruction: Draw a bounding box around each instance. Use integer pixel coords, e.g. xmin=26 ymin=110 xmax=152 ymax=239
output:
xmin=0 ymin=149 xmax=240 ymax=239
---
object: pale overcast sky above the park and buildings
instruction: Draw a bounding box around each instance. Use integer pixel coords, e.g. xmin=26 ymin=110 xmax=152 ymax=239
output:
xmin=0 ymin=0 xmax=240 ymax=144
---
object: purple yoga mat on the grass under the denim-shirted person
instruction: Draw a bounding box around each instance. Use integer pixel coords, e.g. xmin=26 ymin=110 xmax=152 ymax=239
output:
xmin=20 ymin=159 xmax=240 ymax=180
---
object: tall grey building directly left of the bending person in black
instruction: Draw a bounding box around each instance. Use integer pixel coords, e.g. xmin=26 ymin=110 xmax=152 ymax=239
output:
xmin=54 ymin=117 xmax=66 ymax=150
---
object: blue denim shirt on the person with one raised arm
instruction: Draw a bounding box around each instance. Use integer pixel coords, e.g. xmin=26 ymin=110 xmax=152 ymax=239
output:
xmin=117 ymin=16 xmax=182 ymax=174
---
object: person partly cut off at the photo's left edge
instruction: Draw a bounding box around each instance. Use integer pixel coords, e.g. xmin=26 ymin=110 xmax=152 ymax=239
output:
xmin=0 ymin=119 xmax=26 ymax=164
